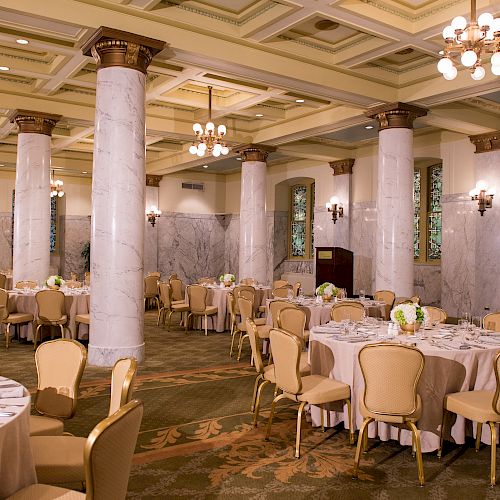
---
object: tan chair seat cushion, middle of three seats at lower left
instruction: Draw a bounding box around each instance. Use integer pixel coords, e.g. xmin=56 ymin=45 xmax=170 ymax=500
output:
xmin=30 ymin=436 xmax=87 ymax=484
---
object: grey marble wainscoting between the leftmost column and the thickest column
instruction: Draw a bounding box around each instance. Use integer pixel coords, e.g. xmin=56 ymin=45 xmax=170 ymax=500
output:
xmin=59 ymin=215 xmax=90 ymax=280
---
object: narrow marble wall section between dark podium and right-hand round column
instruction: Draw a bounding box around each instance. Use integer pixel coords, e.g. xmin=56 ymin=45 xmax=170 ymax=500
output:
xmin=350 ymin=201 xmax=377 ymax=294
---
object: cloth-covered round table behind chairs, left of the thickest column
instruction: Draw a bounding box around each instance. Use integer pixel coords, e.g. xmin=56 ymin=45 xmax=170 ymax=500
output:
xmin=9 ymin=288 xmax=90 ymax=340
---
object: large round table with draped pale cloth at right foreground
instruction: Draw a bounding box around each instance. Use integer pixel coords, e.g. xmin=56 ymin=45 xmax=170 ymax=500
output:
xmin=309 ymin=327 xmax=500 ymax=452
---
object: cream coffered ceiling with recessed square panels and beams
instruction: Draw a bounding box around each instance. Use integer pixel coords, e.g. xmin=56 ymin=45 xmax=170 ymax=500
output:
xmin=0 ymin=0 xmax=500 ymax=175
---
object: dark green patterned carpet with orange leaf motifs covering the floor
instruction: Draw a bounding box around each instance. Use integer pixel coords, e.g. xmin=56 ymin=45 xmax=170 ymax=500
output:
xmin=0 ymin=312 xmax=500 ymax=500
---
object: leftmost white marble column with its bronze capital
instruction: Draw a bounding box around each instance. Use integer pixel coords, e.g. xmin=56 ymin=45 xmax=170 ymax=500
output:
xmin=10 ymin=110 xmax=61 ymax=284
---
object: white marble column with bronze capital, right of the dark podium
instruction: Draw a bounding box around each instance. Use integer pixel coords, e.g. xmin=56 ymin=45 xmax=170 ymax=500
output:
xmin=366 ymin=103 xmax=427 ymax=297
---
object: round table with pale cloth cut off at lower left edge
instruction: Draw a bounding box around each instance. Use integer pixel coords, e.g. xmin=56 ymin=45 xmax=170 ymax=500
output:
xmin=0 ymin=377 xmax=37 ymax=498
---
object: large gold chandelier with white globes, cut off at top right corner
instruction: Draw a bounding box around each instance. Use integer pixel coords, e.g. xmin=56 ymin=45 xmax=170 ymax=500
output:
xmin=438 ymin=0 xmax=500 ymax=80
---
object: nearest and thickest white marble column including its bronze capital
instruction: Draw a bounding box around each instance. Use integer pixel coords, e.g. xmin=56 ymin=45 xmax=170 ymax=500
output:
xmin=82 ymin=27 xmax=165 ymax=366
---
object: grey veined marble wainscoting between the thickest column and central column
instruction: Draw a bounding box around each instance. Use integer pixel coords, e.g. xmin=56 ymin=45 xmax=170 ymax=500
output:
xmin=155 ymin=212 xmax=226 ymax=283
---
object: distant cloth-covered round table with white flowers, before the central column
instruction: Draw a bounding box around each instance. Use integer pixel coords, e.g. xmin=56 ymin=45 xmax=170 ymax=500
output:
xmin=186 ymin=285 xmax=271 ymax=332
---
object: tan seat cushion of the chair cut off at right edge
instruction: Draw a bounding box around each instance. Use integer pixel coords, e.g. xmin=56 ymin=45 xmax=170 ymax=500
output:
xmin=444 ymin=391 xmax=500 ymax=423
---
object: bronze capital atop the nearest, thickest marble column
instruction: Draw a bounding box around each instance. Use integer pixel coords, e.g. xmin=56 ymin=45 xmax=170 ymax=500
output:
xmin=82 ymin=26 xmax=167 ymax=73
